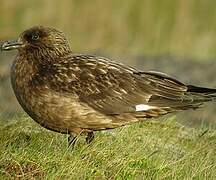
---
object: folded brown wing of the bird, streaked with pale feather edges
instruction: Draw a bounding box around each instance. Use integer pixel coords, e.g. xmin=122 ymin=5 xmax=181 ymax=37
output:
xmin=34 ymin=55 xmax=199 ymax=117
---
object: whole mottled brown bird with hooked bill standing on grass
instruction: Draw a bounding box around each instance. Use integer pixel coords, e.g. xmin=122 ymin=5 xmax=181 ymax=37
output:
xmin=1 ymin=26 xmax=216 ymax=146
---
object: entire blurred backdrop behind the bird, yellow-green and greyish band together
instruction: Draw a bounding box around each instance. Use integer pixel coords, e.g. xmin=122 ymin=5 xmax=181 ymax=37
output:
xmin=0 ymin=0 xmax=216 ymax=124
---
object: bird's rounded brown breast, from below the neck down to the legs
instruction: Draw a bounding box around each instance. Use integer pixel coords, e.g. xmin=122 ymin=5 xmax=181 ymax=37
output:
xmin=11 ymin=59 xmax=78 ymax=133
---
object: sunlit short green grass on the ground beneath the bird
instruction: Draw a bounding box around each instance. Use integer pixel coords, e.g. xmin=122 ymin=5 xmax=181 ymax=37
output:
xmin=0 ymin=116 xmax=216 ymax=179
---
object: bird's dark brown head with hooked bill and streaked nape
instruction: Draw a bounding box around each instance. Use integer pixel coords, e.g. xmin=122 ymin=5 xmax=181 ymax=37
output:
xmin=1 ymin=26 xmax=71 ymax=57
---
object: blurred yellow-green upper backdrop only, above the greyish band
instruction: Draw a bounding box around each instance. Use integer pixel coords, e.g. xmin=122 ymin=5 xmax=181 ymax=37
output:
xmin=0 ymin=0 xmax=216 ymax=58
